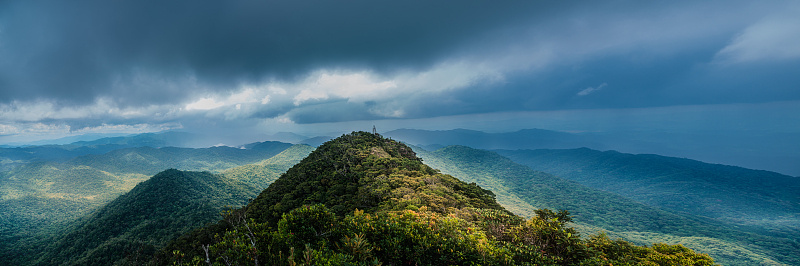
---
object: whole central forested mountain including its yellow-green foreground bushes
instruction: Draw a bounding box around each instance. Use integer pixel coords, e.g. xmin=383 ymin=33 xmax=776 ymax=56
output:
xmin=152 ymin=132 xmax=713 ymax=265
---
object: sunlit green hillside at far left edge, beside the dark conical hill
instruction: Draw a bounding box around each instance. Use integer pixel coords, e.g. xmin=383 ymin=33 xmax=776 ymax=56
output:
xmin=0 ymin=162 xmax=147 ymax=243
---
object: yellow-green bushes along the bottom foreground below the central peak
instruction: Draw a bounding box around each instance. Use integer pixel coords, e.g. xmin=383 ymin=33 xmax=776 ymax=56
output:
xmin=167 ymin=205 xmax=714 ymax=265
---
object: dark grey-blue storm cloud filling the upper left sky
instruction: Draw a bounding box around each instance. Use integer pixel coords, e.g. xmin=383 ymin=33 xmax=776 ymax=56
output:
xmin=0 ymin=1 xmax=544 ymax=106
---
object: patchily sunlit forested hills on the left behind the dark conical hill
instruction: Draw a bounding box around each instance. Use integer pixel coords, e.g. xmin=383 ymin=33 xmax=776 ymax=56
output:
xmin=0 ymin=142 xmax=308 ymax=261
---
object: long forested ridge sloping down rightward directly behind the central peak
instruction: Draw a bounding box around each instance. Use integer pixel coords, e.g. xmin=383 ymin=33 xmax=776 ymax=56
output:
xmin=417 ymin=146 xmax=800 ymax=265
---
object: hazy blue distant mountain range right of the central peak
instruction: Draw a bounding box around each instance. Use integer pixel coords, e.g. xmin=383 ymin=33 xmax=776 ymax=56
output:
xmin=384 ymin=129 xmax=800 ymax=176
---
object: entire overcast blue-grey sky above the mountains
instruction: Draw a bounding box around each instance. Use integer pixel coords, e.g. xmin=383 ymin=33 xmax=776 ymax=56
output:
xmin=0 ymin=0 xmax=800 ymax=144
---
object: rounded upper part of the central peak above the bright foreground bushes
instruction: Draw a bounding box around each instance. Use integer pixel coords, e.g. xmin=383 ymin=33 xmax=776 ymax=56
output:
xmin=247 ymin=132 xmax=503 ymax=223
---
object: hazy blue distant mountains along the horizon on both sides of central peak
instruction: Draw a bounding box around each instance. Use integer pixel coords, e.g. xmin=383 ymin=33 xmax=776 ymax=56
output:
xmin=0 ymin=129 xmax=800 ymax=176
